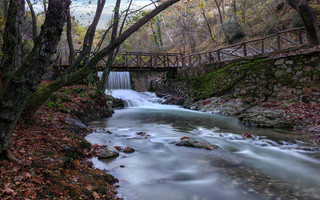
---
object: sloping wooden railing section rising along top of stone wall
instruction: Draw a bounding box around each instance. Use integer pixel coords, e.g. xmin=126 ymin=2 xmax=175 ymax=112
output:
xmin=179 ymin=28 xmax=308 ymax=67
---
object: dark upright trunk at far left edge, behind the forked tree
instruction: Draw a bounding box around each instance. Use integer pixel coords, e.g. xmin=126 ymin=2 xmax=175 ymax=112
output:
xmin=0 ymin=0 xmax=25 ymax=91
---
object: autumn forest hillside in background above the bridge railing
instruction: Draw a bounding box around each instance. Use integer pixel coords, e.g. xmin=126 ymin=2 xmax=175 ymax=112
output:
xmin=0 ymin=0 xmax=320 ymax=59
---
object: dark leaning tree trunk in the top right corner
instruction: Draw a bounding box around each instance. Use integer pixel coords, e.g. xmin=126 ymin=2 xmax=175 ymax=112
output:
xmin=287 ymin=0 xmax=320 ymax=46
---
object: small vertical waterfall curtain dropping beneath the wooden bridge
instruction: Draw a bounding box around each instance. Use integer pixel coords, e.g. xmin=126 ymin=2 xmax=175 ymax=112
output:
xmin=107 ymin=72 xmax=131 ymax=90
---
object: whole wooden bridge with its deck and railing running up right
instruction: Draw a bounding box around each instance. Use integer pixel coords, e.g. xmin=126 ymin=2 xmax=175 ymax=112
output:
xmin=55 ymin=28 xmax=308 ymax=71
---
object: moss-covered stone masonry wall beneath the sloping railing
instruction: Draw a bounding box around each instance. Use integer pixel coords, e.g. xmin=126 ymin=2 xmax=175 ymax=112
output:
xmin=152 ymin=51 xmax=320 ymax=103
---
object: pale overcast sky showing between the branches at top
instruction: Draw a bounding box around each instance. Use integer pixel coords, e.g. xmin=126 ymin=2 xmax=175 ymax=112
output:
xmin=27 ymin=0 xmax=153 ymax=29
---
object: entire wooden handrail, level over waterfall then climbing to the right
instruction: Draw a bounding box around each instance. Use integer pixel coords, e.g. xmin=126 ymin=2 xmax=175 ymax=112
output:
xmin=62 ymin=27 xmax=307 ymax=68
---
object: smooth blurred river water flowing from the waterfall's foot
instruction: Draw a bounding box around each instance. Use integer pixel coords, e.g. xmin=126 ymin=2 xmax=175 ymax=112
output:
xmin=86 ymin=72 xmax=320 ymax=200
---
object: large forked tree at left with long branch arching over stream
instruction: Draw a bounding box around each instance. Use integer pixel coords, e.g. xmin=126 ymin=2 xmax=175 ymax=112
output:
xmin=0 ymin=0 xmax=179 ymax=159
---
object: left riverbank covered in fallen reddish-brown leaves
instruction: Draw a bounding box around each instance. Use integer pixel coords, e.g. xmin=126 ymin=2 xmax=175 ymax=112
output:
xmin=0 ymin=85 xmax=123 ymax=199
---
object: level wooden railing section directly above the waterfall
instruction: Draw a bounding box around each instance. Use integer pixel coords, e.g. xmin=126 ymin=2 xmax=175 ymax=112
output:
xmin=113 ymin=52 xmax=181 ymax=69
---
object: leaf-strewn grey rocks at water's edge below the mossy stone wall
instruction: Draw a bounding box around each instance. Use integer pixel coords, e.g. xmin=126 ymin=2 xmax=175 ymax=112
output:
xmin=160 ymin=94 xmax=320 ymax=138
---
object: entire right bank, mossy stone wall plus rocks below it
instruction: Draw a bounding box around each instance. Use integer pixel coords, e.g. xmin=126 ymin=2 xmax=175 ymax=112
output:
xmin=152 ymin=48 xmax=320 ymax=141
